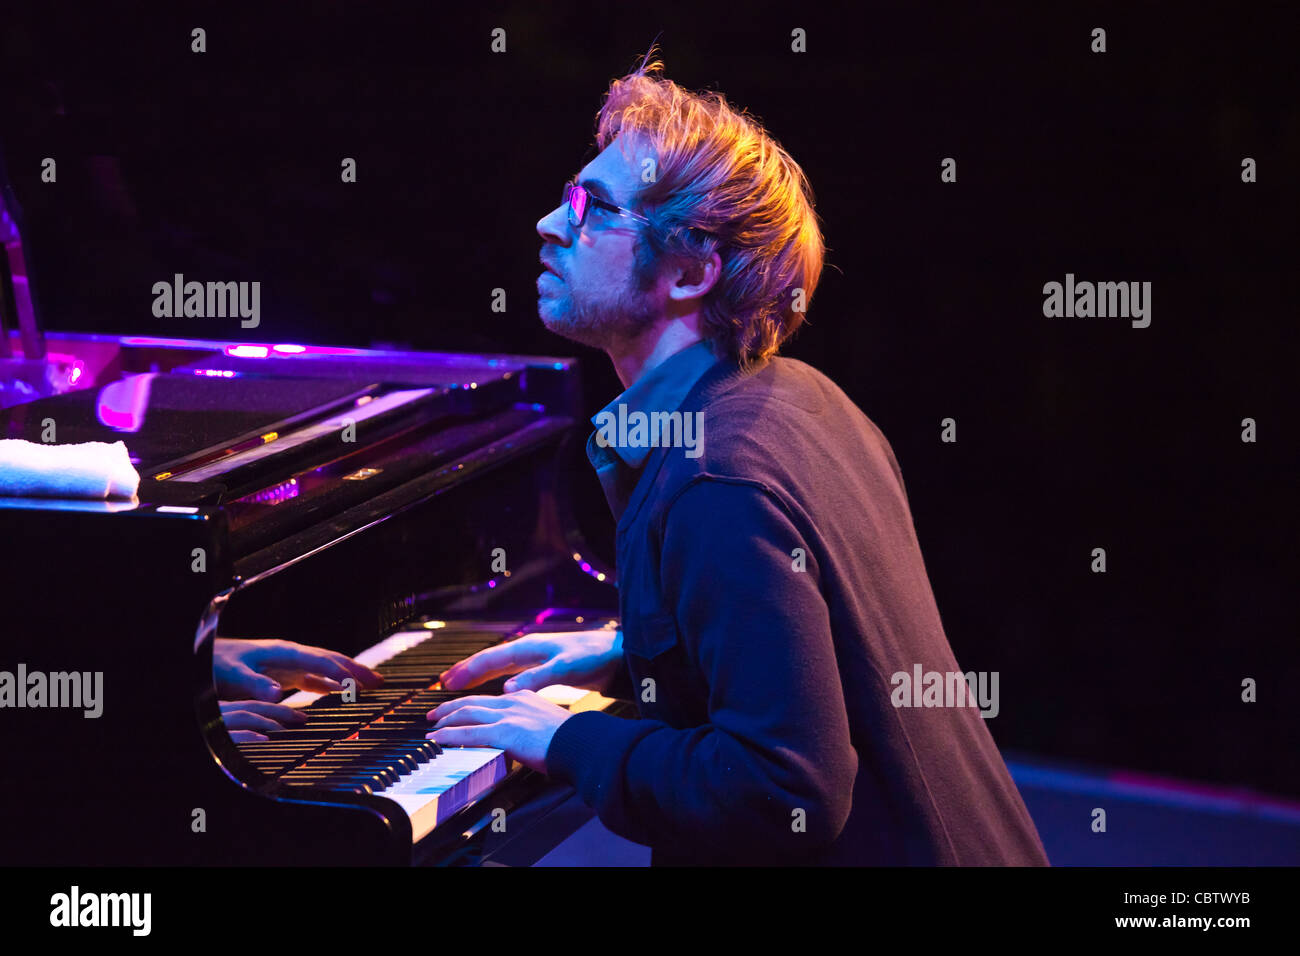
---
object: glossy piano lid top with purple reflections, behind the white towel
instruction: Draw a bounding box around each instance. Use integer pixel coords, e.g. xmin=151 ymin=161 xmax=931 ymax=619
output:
xmin=0 ymin=336 xmax=573 ymax=502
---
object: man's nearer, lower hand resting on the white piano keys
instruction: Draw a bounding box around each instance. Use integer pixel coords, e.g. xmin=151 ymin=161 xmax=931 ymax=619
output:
xmin=425 ymin=682 xmax=572 ymax=774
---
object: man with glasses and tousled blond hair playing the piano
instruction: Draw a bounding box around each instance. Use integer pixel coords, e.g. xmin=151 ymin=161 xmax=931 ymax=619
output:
xmin=429 ymin=51 xmax=1047 ymax=865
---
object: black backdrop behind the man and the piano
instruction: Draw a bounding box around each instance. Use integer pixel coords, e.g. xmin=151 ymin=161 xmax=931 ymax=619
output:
xmin=0 ymin=3 xmax=1300 ymax=795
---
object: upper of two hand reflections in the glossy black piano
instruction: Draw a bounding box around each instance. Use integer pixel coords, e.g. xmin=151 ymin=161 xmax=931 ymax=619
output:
xmin=212 ymin=637 xmax=384 ymax=701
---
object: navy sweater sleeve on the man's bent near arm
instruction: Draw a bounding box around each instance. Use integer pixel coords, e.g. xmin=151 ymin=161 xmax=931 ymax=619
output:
xmin=547 ymin=477 xmax=858 ymax=861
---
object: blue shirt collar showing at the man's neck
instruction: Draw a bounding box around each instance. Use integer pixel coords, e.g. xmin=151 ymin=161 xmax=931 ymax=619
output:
xmin=586 ymin=339 xmax=718 ymax=522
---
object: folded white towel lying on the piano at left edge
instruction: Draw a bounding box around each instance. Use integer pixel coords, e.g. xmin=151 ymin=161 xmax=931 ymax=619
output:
xmin=0 ymin=438 xmax=140 ymax=498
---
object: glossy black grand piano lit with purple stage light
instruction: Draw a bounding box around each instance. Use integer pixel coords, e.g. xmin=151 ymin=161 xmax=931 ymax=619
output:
xmin=0 ymin=167 xmax=620 ymax=865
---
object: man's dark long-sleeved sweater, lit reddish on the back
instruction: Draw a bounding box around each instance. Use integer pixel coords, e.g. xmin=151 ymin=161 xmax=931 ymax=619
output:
xmin=546 ymin=356 xmax=1047 ymax=865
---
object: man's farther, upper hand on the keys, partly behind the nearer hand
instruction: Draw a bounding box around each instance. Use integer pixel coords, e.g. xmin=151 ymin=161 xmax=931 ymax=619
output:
xmin=441 ymin=628 xmax=623 ymax=692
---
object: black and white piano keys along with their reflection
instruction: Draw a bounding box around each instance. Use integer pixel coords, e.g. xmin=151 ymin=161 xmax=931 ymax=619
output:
xmin=238 ymin=622 xmax=608 ymax=842
